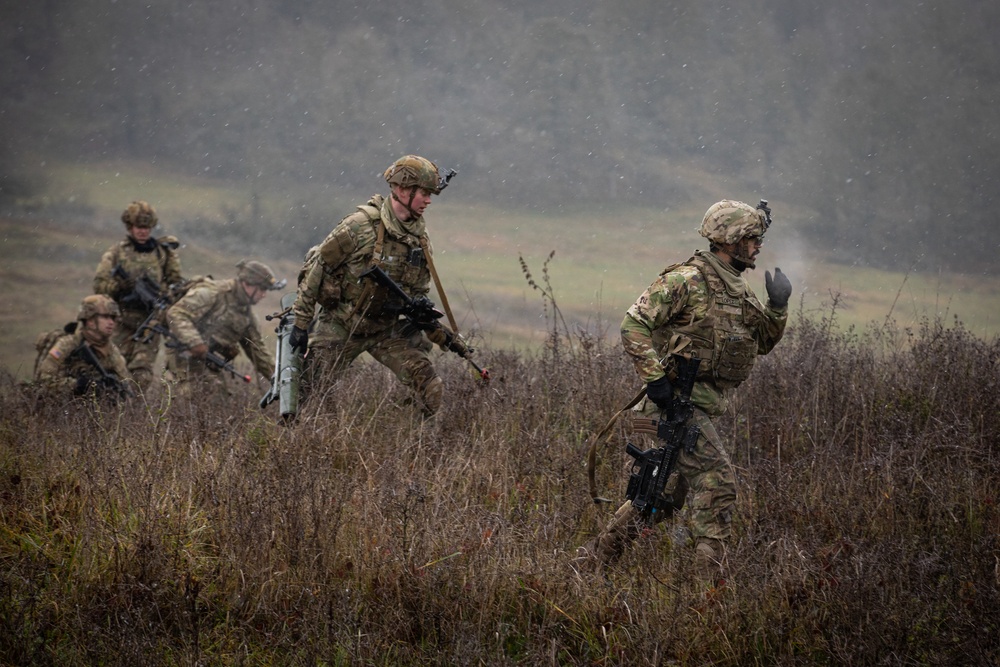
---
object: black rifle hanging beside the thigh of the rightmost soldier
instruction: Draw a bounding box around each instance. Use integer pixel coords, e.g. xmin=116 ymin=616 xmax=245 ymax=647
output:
xmin=625 ymin=355 xmax=701 ymax=523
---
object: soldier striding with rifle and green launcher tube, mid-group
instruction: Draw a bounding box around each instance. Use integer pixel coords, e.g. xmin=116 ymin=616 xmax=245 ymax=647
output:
xmin=291 ymin=155 xmax=468 ymax=416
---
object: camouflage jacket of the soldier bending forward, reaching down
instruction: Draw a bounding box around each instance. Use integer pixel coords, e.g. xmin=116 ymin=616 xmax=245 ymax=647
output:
xmin=167 ymin=278 xmax=274 ymax=377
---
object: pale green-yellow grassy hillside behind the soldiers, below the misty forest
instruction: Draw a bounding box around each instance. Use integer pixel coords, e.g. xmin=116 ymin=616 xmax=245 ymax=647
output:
xmin=0 ymin=166 xmax=1000 ymax=378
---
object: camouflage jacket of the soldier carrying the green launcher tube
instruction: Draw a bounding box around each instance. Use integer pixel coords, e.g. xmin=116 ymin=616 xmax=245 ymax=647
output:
xmin=293 ymin=195 xmax=431 ymax=335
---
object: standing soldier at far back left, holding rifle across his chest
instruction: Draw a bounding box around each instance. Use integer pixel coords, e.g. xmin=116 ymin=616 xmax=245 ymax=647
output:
xmin=94 ymin=201 xmax=182 ymax=389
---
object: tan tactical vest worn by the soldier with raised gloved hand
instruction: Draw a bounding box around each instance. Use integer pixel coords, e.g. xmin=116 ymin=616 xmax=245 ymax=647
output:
xmin=653 ymin=256 xmax=764 ymax=389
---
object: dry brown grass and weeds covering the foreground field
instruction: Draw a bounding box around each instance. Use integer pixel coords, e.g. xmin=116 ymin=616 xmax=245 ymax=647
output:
xmin=0 ymin=303 xmax=1000 ymax=665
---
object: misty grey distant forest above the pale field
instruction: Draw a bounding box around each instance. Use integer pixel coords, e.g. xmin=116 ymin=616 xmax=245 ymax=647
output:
xmin=0 ymin=0 xmax=1000 ymax=272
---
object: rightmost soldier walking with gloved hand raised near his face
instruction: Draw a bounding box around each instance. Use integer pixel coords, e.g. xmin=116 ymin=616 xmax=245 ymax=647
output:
xmin=584 ymin=200 xmax=792 ymax=584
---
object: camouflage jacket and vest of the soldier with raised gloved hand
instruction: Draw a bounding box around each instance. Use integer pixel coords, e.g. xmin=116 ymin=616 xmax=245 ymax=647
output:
xmin=621 ymin=251 xmax=788 ymax=415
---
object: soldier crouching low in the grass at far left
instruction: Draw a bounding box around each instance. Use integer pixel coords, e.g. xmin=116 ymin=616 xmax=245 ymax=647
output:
xmin=35 ymin=294 xmax=132 ymax=398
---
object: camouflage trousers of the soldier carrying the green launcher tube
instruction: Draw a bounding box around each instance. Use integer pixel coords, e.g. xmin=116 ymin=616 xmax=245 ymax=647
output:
xmin=302 ymin=319 xmax=444 ymax=415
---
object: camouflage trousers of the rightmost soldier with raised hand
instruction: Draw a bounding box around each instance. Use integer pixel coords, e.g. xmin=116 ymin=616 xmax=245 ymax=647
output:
xmin=593 ymin=408 xmax=736 ymax=579
